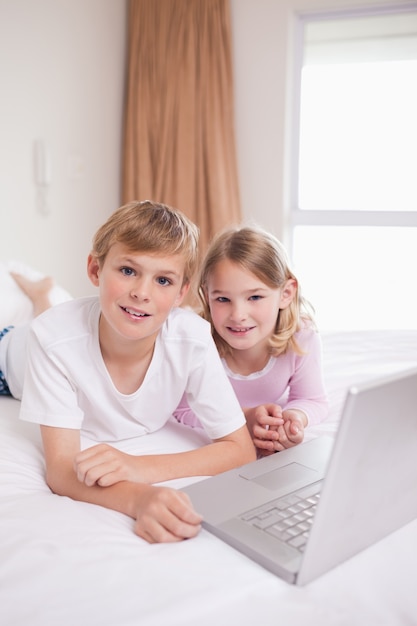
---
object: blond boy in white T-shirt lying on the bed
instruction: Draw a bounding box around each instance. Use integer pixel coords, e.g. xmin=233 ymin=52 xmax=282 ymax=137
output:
xmin=4 ymin=201 xmax=255 ymax=542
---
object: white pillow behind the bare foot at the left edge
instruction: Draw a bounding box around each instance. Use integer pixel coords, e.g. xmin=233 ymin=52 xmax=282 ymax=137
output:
xmin=0 ymin=260 xmax=72 ymax=330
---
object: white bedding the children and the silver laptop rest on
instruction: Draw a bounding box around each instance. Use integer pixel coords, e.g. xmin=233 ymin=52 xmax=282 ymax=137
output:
xmin=0 ymin=331 xmax=417 ymax=626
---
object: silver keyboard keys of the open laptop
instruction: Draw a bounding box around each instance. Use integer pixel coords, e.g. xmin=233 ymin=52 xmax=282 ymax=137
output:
xmin=240 ymin=482 xmax=321 ymax=552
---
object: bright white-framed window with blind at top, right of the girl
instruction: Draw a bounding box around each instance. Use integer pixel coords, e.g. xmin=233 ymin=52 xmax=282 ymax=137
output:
xmin=291 ymin=9 xmax=417 ymax=330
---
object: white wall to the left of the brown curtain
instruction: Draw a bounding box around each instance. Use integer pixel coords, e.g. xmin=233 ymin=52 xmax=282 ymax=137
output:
xmin=0 ymin=0 xmax=126 ymax=296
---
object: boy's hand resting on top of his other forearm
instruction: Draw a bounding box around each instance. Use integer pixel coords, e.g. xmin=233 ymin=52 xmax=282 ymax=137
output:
xmin=74 ymin=443 xmax=150 ymax=487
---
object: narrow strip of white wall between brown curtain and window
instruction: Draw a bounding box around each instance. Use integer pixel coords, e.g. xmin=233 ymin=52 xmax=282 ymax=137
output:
xmin=230 ymin=0 xmax=408 ymax=243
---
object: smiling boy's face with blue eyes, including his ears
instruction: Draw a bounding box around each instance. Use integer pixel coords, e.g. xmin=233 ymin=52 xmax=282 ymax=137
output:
xmin=87 ymin=243 xmax=189 ymax=341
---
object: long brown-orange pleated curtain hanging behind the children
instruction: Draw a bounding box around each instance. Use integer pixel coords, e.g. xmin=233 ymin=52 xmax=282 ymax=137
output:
xmin=123 ymin=0 xmax=241 ymax=252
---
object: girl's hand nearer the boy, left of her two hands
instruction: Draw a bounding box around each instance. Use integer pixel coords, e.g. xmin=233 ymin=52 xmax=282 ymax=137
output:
xmin=244 ymin=404 xmax=284 ymax=456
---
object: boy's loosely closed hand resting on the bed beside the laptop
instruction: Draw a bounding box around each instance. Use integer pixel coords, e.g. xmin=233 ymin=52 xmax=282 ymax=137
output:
xmin=135 ymin=486 xmax=202 ymax=543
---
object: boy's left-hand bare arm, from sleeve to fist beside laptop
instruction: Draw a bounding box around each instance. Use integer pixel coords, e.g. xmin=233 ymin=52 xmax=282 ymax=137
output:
xmin=41 ymin=426 xmax=202 ymax=543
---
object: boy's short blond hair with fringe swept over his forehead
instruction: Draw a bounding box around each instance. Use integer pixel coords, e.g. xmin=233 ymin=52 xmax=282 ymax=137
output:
xmin=91 ymin=200 xmax=199 ymax=284
